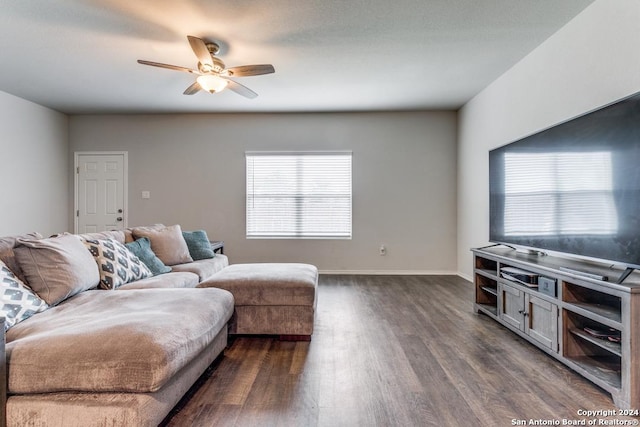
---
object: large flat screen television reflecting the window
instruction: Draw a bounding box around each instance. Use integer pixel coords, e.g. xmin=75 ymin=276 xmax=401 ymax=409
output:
xmin=489 ymin=94 xmax=640 ymax=280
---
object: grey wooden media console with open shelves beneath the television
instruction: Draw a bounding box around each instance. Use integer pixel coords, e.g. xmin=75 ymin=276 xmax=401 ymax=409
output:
xmin=472 ymin=246 xmax=640 ymax=409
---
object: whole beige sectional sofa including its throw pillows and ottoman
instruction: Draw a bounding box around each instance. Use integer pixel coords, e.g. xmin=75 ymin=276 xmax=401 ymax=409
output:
xmin=0 ymin=224 xmax=318 ymax=427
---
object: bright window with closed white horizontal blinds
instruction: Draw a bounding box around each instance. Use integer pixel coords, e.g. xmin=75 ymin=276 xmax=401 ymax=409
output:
xmin=246 ymin=152 xmax=351 ymax=239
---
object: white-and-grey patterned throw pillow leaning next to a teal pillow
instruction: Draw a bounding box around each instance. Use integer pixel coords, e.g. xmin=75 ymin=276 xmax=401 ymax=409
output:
xmin=84 ymin=239 xmax=153 ymax=289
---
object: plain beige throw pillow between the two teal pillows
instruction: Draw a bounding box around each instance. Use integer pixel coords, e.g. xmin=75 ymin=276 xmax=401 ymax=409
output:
xmin=132 ymin=225 xmax=193 ymax=265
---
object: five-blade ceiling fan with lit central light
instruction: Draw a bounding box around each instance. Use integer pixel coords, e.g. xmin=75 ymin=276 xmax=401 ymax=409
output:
xmin=138 ymin=36 xmax=276 ymax=98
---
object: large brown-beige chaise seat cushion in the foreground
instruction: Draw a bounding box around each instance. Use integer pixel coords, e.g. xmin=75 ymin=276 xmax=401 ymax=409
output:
xmin=7 ymin=289 xmax=233 ymax=393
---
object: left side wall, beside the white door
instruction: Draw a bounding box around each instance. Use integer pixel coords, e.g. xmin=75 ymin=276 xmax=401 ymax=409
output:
xmin=0 ymin=92 xmax=70 ymax=236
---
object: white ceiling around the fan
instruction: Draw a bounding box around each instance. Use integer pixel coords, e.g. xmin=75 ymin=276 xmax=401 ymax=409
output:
xmin=0 ymin=0 xmax=593 ymax=114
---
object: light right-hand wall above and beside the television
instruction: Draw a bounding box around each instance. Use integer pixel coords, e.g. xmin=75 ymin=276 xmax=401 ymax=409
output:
xmin=457 ymin=0 xmax=640 ymax=277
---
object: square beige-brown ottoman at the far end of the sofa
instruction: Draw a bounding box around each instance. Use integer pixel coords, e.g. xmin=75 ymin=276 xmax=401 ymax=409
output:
xmin=198 ymin=263 xmax=318 ymax=341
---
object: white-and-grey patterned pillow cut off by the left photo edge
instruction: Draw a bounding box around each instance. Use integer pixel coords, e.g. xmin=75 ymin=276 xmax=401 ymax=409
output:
xmin=0 ymin=261 xmax=49 ymax=331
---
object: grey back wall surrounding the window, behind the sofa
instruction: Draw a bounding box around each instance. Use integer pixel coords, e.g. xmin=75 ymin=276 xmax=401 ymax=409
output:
xmin=70 ymin=112 xmax=457 ymax=273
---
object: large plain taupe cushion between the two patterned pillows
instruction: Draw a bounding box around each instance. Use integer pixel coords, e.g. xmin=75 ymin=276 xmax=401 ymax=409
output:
xmin=14 ymin=234 xmax=100 ymax=305
